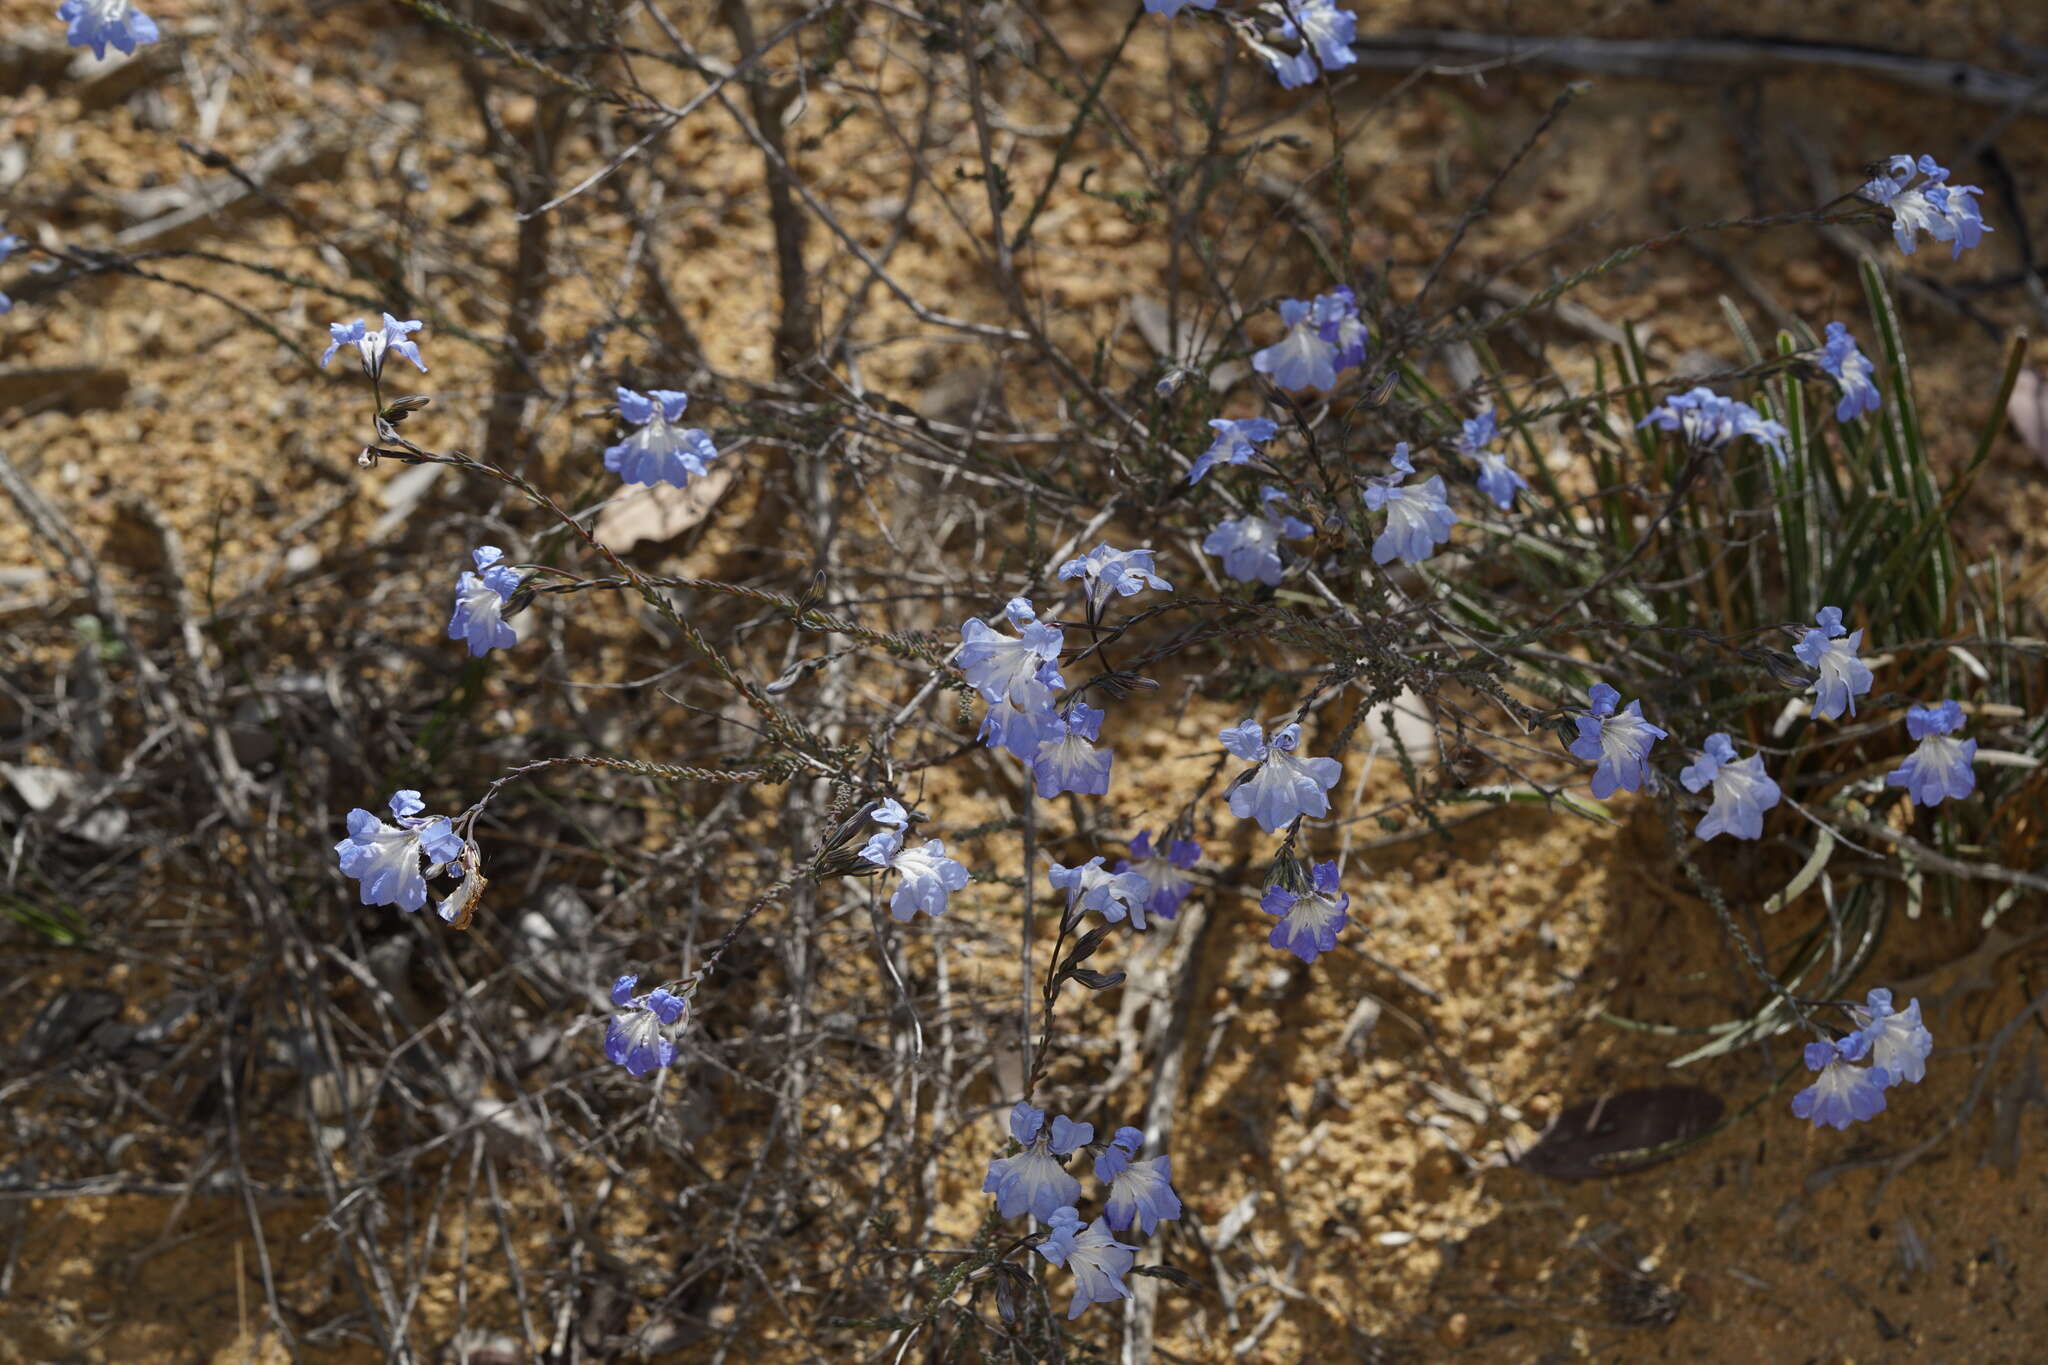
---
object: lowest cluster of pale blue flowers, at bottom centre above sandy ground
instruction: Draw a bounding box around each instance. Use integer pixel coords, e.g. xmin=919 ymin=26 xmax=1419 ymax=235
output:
xmin=981 ymin=1101 xmax=1182 ymax=1318
